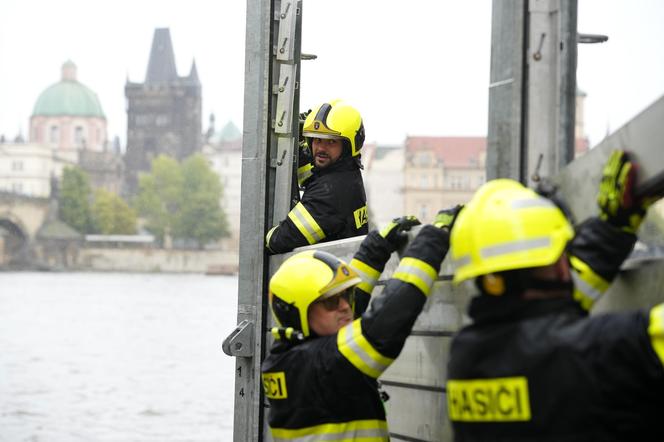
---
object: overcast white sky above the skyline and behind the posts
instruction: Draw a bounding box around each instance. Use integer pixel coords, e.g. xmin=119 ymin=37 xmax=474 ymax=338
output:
xmin=0 ymin=0 xmax=664 ymax=148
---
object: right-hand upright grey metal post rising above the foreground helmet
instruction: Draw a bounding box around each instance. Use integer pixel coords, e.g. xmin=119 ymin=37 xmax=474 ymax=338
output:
xmin=487 ymin=0 xmax=577 ymax=185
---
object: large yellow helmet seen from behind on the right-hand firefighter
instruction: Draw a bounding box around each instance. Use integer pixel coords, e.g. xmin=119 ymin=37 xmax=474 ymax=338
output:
xmin=450 ymin=179 xmax=574 ymax=283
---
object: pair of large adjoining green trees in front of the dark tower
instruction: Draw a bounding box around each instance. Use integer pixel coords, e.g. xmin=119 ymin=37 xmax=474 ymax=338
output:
xmin=135 ymin=155 xmax=228 ymax=246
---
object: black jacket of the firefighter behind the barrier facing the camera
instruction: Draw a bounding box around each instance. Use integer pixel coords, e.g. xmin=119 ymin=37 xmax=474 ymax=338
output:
xmin=265 ymin=157 xmax=369 ymax=253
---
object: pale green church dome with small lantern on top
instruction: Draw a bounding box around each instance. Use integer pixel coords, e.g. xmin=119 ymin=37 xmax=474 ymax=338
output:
xmin=32 ymin=61 xmax=106 ymax=118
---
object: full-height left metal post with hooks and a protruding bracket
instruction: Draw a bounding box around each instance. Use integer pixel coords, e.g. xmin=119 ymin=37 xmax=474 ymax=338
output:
xmin=222 ymin=0 xmax=302 ymax=442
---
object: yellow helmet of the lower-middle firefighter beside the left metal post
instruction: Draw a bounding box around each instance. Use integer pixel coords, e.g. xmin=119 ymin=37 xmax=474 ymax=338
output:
xmin=269 ymin=250 xmax=362 ymax=336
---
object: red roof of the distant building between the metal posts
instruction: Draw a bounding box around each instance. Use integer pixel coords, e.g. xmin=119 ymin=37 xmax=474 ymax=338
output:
xmin=406 ymin=137 xmax=486 ymax=167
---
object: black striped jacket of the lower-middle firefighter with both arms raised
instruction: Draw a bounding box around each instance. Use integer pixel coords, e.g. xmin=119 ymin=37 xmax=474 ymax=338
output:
xmin=262 ymin=226 xmax=448 ymax=441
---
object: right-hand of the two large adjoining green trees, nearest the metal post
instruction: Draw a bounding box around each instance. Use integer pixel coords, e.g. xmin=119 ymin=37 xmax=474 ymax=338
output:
xmin=174 ymin=154 xmax=228 ymax=247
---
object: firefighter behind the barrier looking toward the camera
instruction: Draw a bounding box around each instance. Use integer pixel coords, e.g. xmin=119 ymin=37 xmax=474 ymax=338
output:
xmin=265 ymin=100 xmax=369 ymax=253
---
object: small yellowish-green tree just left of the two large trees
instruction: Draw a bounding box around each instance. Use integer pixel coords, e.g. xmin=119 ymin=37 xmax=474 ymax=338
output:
xmin=92 ymin=189 xmax=136 ymax=235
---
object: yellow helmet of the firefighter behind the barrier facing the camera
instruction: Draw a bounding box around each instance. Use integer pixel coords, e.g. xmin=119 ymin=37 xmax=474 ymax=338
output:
xmin=302 ymin=100 xmax=364 ymax=157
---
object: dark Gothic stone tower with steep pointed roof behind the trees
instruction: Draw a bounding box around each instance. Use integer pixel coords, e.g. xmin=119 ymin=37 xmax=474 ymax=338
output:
xmin=125 ymin=28 xmax=202 ymax=195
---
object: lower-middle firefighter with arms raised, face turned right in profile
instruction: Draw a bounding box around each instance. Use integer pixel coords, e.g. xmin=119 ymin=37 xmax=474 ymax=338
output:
xmin=262 ymin=208 xmax=458 ymax=442
